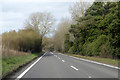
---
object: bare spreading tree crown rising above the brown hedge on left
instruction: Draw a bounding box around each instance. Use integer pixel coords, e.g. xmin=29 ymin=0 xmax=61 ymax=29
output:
xmin=25 ymin=12 xmax=55 ymax=38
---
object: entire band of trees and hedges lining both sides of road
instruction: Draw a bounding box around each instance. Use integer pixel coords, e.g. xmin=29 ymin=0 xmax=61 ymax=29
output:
xmin=2 ymin=2 xmax=120 ymax=59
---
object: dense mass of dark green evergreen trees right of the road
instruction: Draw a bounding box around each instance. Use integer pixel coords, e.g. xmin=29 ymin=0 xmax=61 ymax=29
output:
xmin=64 ymin=2 xmax=120 ymax=59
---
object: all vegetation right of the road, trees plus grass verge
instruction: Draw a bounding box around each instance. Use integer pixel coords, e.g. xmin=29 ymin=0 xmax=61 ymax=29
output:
xmin=53 ymin=2 xmax=120 ymax=66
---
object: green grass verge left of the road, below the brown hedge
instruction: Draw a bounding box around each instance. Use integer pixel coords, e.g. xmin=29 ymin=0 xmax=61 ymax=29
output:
xmin=2 ymin=52 xmax=43 ymax=76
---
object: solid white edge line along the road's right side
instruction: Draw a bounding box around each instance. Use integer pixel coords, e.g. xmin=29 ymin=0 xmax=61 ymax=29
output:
xmin=59 ymin=53 xmax=120 ymax=69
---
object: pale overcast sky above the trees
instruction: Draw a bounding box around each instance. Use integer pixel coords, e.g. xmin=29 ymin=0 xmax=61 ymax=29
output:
xmin=0 ymin=1 xmax=76 ymax=33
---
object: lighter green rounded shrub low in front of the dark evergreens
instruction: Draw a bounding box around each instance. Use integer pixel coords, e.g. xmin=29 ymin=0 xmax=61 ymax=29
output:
xmin=83 ymin=35 xmax=109 ymax=56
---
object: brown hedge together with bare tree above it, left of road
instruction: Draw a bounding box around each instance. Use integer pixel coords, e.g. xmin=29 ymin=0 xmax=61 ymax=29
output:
xmin=2 ymin=12 xmax=55 ymax=57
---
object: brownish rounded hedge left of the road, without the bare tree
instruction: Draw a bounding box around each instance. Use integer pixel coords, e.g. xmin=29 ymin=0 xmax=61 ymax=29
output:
xmin=2 ymin=29 xmax=42 ymax=53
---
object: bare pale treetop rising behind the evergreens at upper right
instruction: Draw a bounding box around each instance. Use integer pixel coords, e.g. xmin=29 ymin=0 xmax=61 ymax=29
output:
xmin=69 ymin=0 xmax=90 ymax=21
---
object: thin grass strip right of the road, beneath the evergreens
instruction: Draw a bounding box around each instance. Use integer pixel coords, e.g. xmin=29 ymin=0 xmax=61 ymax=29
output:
xmin=62 ymin=54 xmax=120 ymax=66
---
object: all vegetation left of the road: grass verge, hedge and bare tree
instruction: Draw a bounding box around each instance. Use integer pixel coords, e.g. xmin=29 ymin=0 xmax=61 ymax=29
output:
xmin=2 ymin=12 xmax=55 ymax=77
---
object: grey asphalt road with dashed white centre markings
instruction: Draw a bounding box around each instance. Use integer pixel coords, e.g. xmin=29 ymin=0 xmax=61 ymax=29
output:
xmin=16 ymin=52 xmax=118 ymax=78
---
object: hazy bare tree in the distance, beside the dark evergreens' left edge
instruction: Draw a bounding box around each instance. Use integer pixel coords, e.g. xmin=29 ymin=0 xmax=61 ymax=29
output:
xmin=53 ymin=18 xmax=71 ymax=51
